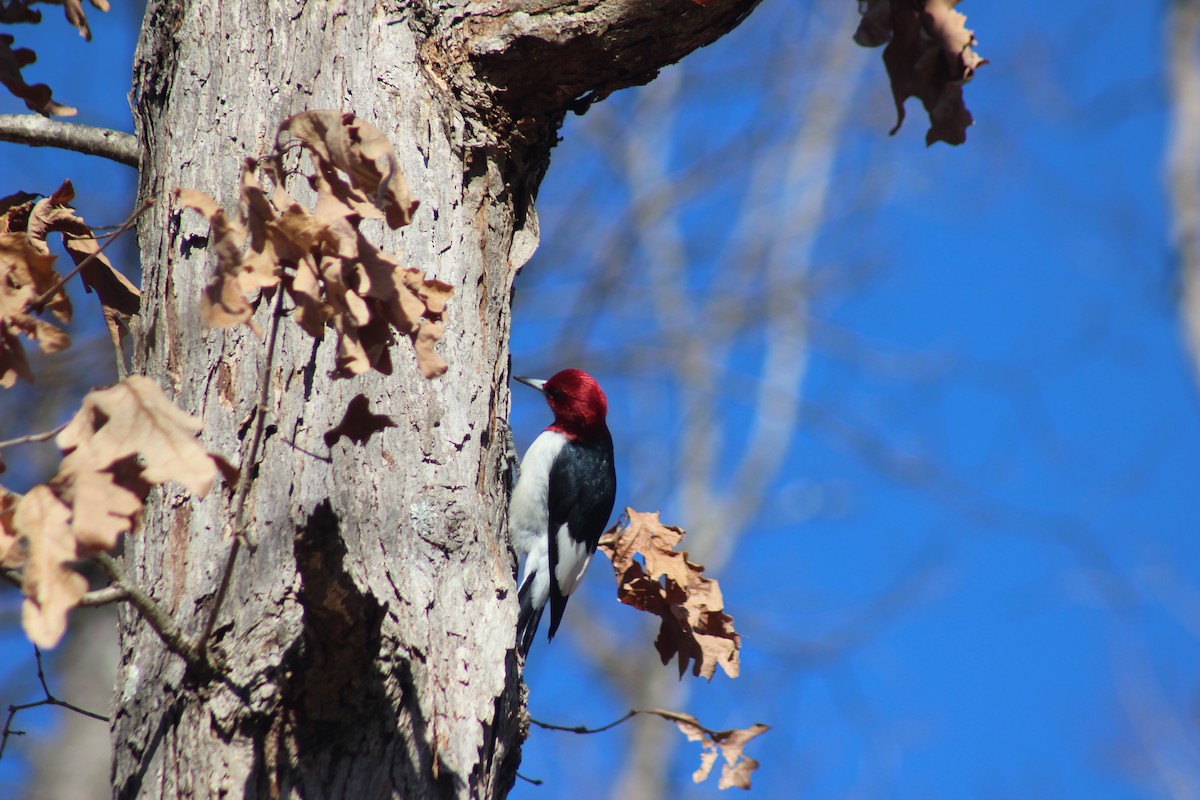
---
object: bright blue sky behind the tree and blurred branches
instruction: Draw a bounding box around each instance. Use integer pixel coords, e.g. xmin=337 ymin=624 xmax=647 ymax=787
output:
xmin=0 ymin=0 xmax=1200 ymax=799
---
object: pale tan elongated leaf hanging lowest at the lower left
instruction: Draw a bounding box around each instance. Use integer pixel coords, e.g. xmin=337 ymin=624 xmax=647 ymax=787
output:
xmin=13 ymin=486 xmax=88 ymax=648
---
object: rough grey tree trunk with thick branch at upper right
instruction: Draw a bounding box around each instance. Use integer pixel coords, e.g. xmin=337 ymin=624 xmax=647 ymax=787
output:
xmin=113 ymin=0 xmax=757 ymax=798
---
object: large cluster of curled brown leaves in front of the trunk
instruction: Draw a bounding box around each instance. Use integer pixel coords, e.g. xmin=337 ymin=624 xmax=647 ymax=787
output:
xmin=175 ymin=110 xmax=454 ymax=378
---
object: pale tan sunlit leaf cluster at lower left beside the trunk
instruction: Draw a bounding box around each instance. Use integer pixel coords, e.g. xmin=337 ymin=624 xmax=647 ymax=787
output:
xmin=0 ymin=375 xmax=236 ymax=648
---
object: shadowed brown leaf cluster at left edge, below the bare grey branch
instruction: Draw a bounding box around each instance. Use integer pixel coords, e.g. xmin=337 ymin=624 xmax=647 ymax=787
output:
xmin=0 ymin=181 xmax=142 ymax=387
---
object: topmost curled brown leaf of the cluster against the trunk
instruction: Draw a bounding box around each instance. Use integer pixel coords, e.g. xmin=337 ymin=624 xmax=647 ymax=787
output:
xmin=280 ymin=110 xmax=420 ymax=229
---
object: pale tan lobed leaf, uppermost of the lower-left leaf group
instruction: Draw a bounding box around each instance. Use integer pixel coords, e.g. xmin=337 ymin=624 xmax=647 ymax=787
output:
xmin=55 ymin=375 xmax=234 ymax=494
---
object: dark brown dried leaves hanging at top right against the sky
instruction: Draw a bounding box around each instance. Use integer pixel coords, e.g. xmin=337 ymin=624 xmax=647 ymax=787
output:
xmin=854 ymin=0 xmax=988 ymax=144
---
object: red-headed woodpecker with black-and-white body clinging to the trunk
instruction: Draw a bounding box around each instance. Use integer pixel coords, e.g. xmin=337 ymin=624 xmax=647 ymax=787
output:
xmin=509 ymin=369 xmax=617 ymax=656
